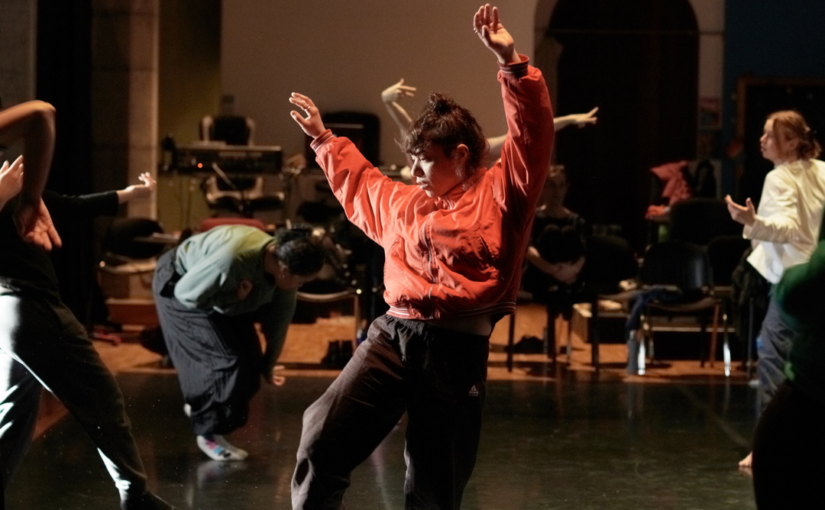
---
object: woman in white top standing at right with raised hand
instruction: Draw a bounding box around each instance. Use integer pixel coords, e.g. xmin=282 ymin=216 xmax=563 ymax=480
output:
xmin=726 ymin=110 xmax=825 ymax=468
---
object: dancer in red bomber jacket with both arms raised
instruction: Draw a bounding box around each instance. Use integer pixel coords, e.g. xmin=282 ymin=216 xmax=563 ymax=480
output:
xmin=290 ymin=5 xmax=553 ymax=509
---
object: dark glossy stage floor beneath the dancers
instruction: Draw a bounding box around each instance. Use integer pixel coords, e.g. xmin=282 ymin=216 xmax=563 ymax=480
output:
xmin=6 ymin=371 xmax=755 ymax=510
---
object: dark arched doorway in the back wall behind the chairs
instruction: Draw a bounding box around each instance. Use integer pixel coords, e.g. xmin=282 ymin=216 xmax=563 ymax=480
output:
xmin=536 ymin=0 xmax=699 ymax=249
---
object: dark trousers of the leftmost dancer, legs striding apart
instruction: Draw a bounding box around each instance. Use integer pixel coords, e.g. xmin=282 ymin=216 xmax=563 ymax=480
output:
xmin=0 ymin=284 xmax=146 ymax=499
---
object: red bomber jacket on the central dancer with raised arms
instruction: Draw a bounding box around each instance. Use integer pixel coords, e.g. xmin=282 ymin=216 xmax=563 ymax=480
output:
xmin=312 ymin=56 xmax=554 ymax=319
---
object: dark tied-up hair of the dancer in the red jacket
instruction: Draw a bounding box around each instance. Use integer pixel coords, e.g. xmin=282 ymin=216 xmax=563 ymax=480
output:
xmin=398 ymin=92 xmax=489 ymax=181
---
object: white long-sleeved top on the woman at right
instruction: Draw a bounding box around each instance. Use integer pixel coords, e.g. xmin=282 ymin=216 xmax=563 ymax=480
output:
xmin=742 ymin=159 xmax=825 ymax=283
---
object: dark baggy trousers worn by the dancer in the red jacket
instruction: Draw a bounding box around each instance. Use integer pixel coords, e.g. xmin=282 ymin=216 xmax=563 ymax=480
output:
xmin=292 ymin=315 xmax=489 ymax=510
